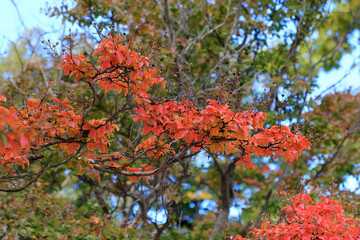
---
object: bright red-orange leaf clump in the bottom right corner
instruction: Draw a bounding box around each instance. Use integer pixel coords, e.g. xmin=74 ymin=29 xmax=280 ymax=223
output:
xmin=232 ymin=194 xmax=360 ymax=240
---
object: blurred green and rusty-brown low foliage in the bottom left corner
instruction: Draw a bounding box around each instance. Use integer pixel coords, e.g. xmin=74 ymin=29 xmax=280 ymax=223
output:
xmin=0 ymin=185 xmax=123 ymax=239
